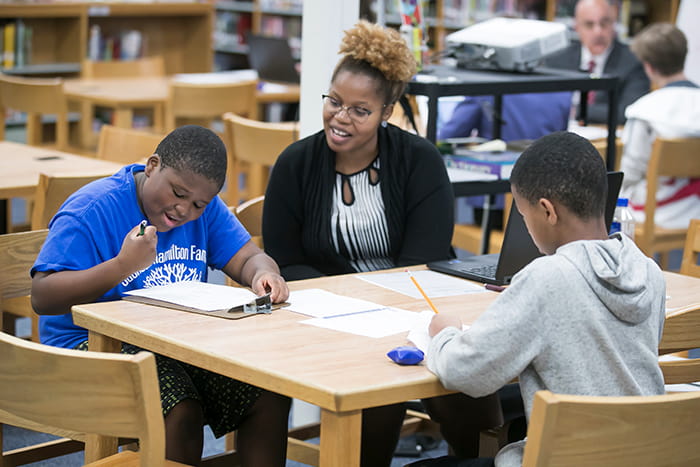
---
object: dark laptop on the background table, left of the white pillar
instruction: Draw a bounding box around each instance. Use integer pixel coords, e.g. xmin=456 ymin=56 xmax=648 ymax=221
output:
xmin=246 ymin=34 xmax=299 ymax=84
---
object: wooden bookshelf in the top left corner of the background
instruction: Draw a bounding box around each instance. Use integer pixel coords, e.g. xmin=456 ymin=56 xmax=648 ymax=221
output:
xmin=0 ymin=1 xmax=214 ymax=76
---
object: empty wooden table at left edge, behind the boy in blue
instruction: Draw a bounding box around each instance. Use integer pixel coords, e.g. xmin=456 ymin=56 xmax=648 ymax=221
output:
xmin=0 ymin=141 xmax=122 ymax=233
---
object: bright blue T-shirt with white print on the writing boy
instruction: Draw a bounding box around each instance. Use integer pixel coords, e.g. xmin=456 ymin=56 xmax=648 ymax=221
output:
xmin=31 ymin=164 xmax=250 ymax=348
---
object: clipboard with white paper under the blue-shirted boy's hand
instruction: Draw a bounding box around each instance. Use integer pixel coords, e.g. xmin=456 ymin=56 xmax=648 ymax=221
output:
xmin=123 ymin=281 xmax=279 ymax=319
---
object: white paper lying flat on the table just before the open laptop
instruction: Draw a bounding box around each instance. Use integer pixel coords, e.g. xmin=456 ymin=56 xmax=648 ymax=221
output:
xmin=357 ymin=271 xmax=486 ymax=299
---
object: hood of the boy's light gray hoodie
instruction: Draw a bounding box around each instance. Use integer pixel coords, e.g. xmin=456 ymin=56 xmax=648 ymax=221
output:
xmin=557 ymin=234 xmax=658 ymax=324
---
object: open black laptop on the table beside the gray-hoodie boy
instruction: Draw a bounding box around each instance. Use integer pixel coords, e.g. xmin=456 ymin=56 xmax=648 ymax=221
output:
xmin=427 ymin=172 xmax=622 ymax=285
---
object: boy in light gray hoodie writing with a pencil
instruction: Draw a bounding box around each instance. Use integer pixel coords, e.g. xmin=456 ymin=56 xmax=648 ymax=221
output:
xmin=418 ymin=132 xmax=665 ymax=467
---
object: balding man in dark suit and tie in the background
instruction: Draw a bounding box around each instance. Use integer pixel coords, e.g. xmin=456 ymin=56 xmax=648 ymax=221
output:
xmin=547 ymin=0 xmax=649 ymax=124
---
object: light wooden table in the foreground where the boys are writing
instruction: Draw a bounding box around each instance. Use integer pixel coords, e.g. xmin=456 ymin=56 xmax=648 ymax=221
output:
xmin=73 ymin=268 xmax=700 ymax=467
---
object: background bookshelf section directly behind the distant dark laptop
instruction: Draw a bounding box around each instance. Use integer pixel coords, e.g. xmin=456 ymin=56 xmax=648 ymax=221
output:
xmin=214 ymin=0 xmax=303 ymax=69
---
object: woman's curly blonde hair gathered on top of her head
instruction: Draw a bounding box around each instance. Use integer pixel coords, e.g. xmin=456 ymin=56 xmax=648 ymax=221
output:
xmin=331 ymin=20 xmax=417 ymax=104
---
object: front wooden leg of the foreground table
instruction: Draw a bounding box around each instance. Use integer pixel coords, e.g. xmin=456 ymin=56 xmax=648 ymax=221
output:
xmin=319 ymin=409 xmax=362 ymax=467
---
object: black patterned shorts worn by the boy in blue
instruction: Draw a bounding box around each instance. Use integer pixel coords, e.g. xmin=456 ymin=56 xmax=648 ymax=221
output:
xmin=75 ymin=341 xmax=262 ymax=438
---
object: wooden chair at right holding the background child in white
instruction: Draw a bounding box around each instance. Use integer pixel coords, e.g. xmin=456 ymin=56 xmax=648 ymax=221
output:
xmin=634 ymin=138 xmax=700 ymax=269
